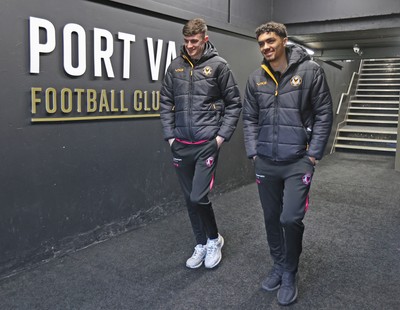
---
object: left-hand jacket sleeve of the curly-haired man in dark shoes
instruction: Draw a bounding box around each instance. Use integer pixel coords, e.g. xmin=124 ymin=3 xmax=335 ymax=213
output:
xmin=243 ymin=79 xmax=259 ymax=158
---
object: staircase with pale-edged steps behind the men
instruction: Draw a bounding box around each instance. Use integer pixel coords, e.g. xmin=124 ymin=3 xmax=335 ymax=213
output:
xmin=332 ymin=58 xmax=400 ymax=155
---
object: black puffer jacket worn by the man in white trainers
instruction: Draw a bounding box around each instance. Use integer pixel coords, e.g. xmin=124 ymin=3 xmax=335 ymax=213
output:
xmin=160 ymin=42 xmax=242 ymax=142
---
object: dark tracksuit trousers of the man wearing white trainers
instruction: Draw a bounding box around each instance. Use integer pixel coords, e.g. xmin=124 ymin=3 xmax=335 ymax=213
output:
xmin=171 ymin=139 xmax=219 ymax=245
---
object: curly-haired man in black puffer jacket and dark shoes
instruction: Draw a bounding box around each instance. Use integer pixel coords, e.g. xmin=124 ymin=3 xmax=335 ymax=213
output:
xmin=243 ymin=22 xmax=332 ymax=305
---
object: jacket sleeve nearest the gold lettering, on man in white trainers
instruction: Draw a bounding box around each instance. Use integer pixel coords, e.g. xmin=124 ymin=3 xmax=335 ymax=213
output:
xmin=160 ymin=71 xmax=175 ymax=140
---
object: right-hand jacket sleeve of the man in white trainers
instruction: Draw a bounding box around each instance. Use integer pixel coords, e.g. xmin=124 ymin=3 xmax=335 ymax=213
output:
xmin=218 ymin=64 xmax=242 ymax=141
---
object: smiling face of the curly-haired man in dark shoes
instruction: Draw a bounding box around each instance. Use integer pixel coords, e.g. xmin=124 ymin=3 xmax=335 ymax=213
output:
xmin=257 ymin=31 xmax=288 ymax=64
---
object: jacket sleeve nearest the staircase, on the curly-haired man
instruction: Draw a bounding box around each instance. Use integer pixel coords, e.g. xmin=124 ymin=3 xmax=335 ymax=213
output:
xmin=307 ymin=68 xmax=333 ymax=159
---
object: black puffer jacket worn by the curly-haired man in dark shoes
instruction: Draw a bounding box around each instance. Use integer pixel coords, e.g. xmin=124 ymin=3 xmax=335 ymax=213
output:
xmin=243 ymin=45 xmax=332 ymax=161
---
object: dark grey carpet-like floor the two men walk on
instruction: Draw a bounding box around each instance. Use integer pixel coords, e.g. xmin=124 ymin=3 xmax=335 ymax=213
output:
xmin=0 ymin=153 xmax=400 ymax=310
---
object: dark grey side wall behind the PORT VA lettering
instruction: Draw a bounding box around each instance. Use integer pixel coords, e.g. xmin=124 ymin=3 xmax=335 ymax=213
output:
xmin=0 ymin=0 xmax=261 ymax=274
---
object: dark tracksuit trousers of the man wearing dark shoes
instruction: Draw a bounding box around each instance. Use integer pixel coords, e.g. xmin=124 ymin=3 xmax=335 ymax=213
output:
xmin=255 ymin=156 xmax=314 ymax=273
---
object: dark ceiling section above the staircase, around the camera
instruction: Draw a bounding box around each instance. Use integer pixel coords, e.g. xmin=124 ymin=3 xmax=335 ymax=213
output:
xmin=287 ymin=14 xmax=400 ymax=60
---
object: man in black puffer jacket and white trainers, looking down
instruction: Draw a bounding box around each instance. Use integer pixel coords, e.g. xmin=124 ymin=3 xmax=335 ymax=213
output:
xmin=161 ymin=18 xmax=241 ymax=268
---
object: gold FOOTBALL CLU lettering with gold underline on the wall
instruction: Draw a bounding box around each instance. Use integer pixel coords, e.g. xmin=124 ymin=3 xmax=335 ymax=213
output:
xmin=31 ymin=87 xmax=160 ymax=122
